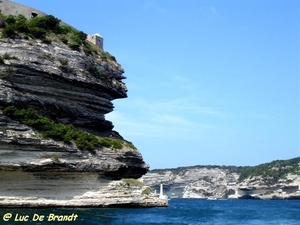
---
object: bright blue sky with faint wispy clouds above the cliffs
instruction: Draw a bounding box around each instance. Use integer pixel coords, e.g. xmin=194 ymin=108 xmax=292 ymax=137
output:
xmin=15 ymin=0 xmax=300 ymax=169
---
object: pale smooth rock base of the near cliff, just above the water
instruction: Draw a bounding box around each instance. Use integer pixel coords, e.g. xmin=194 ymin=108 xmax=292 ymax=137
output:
xmin=0 ymin=170 xmax=168 ymax=207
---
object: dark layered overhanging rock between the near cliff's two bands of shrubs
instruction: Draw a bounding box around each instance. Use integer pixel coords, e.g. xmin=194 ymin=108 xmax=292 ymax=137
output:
xmin=0 ymin=39 xmax=127 ymax=134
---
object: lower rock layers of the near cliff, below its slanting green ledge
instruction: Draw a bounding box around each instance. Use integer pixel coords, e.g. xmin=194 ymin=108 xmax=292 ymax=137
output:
xmin=0 ymin=113 xmax=168 ymax=207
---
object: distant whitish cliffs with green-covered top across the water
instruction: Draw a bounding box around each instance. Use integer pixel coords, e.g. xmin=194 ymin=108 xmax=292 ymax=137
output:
xmin=141 ymin=158 xmax=300 ymax=199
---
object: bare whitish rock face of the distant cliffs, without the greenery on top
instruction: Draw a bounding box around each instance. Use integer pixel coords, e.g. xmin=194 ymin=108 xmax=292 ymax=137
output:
xmin=140 ymin=165 xmax=300 ymax=199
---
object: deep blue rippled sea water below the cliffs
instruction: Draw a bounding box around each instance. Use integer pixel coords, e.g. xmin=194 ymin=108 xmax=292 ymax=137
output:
xmin=0 ymin=199 xmax=300 ymax=225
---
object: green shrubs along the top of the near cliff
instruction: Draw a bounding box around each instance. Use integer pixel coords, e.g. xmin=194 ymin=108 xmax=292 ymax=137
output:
xmin=0 ymin=11 xmax=116 ymax=62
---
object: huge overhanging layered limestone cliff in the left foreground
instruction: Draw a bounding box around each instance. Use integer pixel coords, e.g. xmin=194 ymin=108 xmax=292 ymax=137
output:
xmin=0 ymin=1 xmax=167 ymax=207
